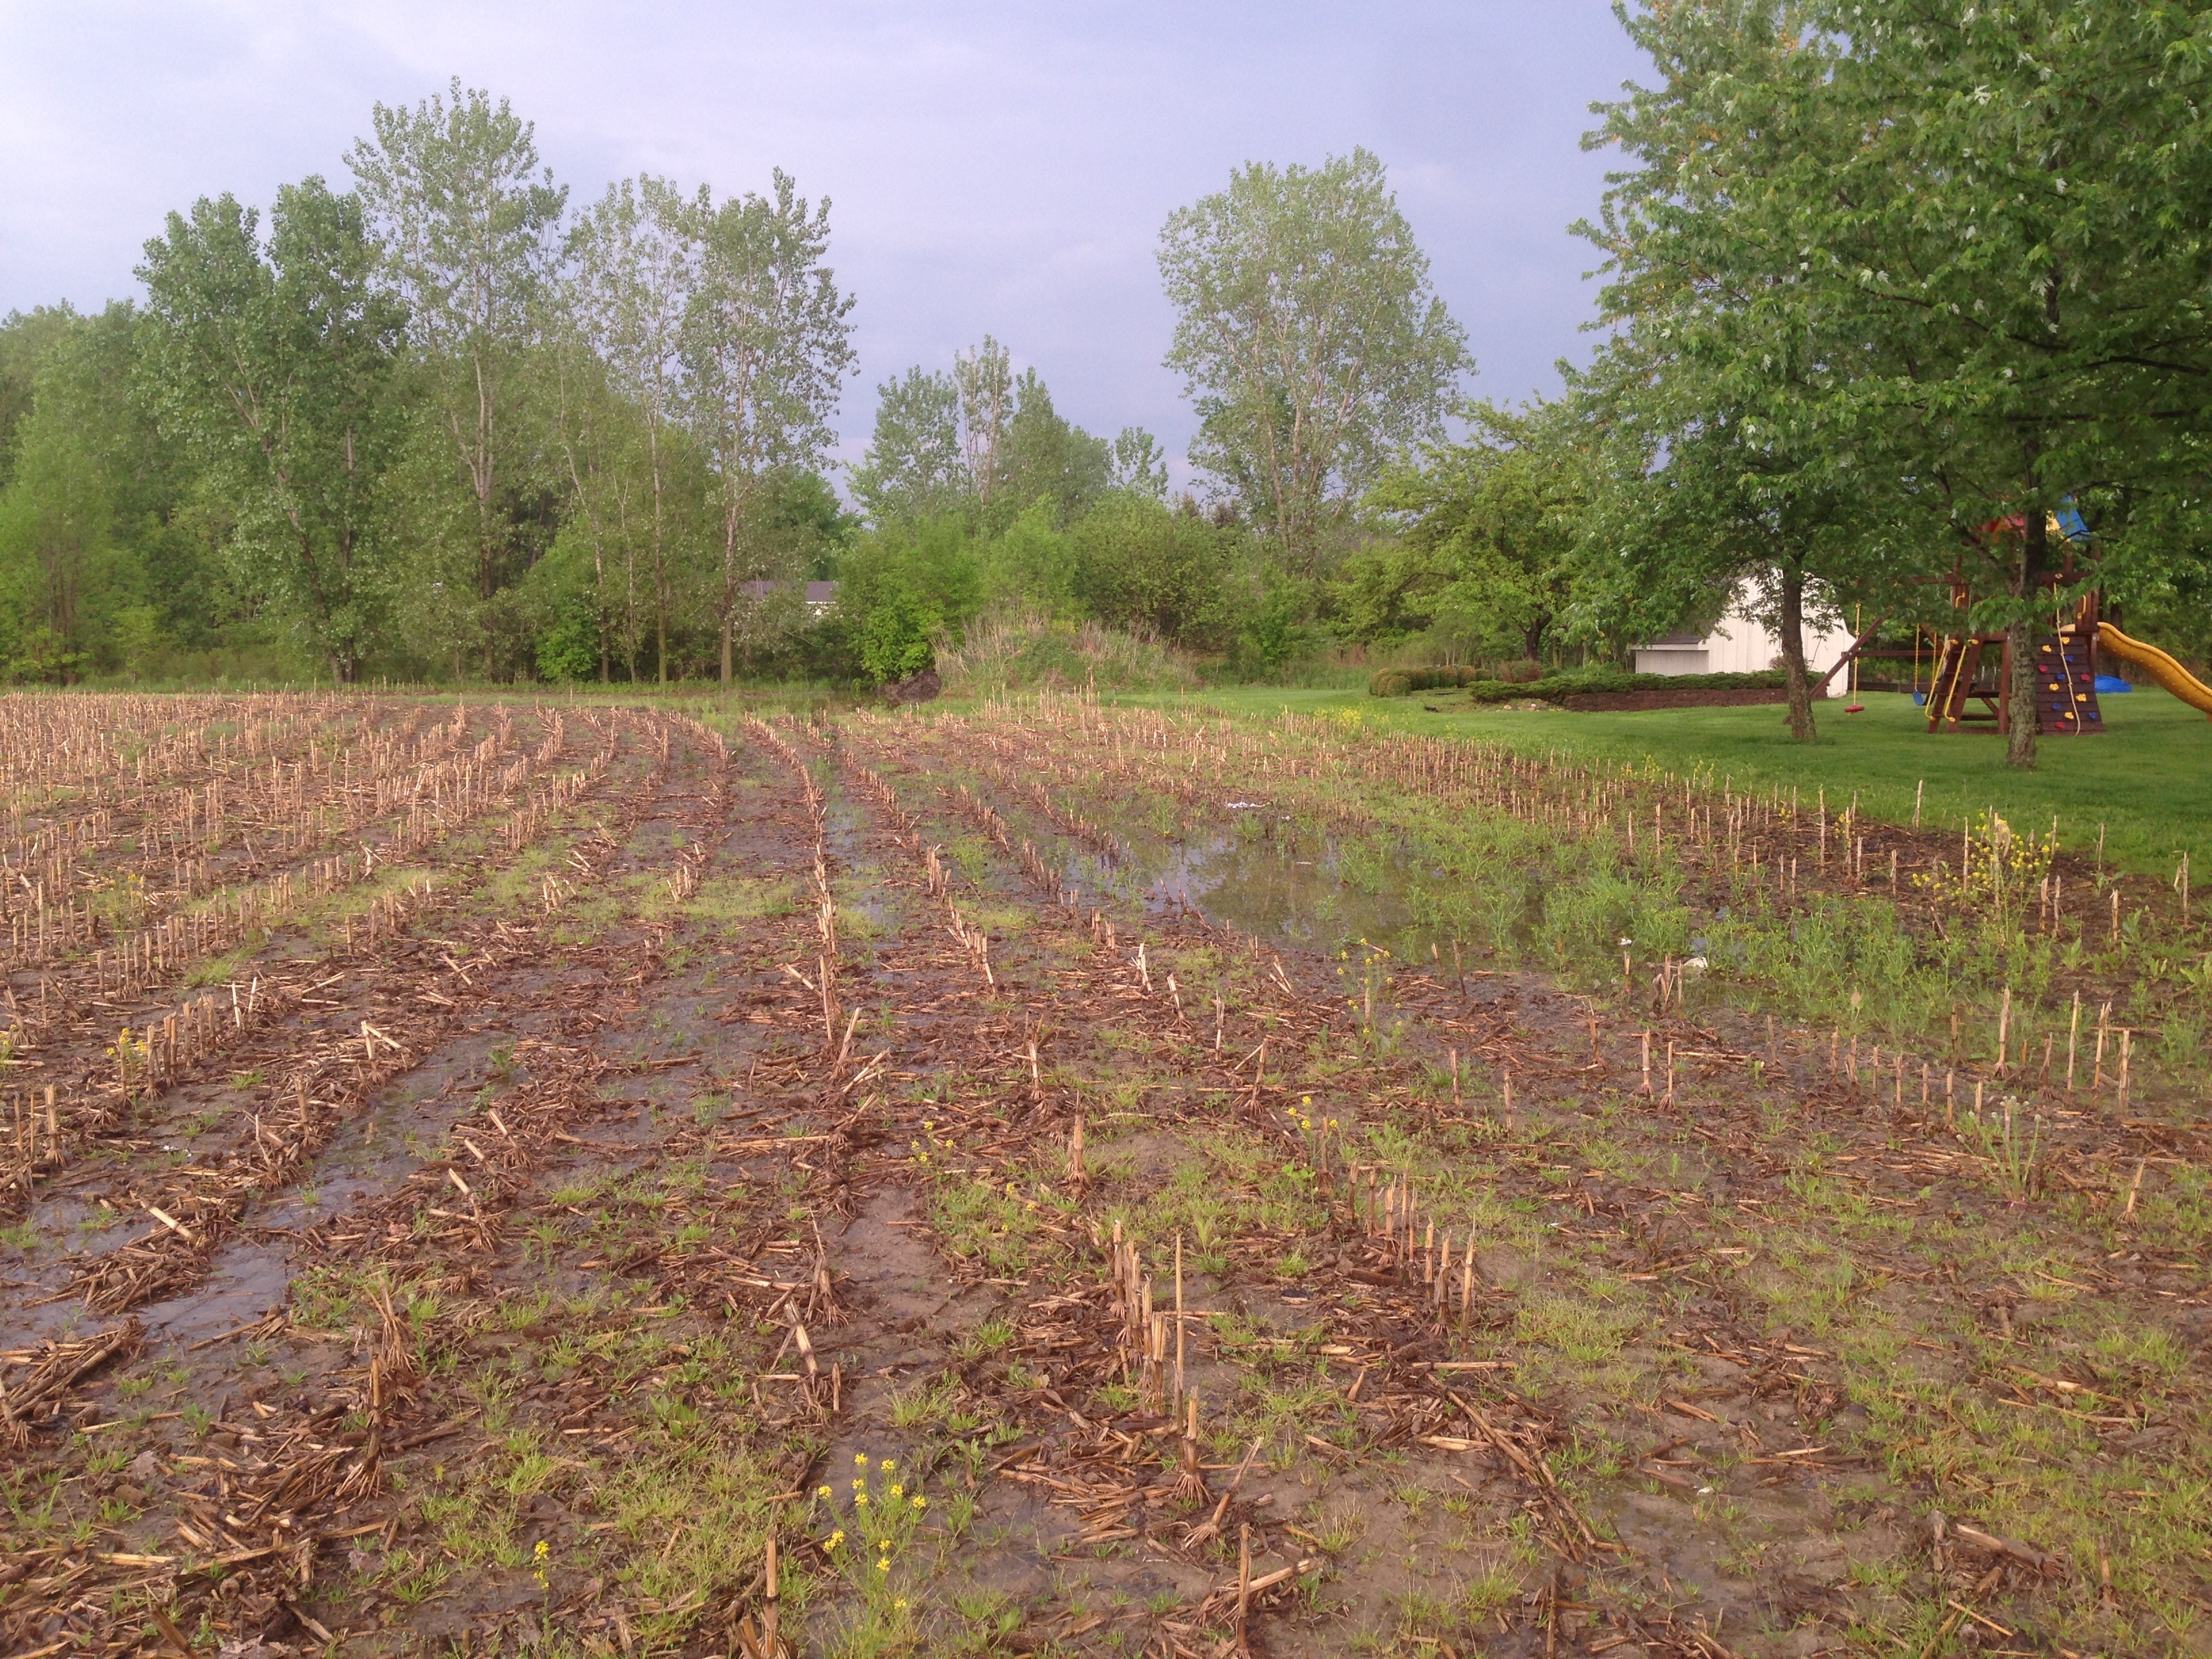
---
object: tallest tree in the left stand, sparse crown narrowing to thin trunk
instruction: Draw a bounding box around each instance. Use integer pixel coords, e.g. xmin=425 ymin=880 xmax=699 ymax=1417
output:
xmin=347 ymin=75 xmax=569 ymax=670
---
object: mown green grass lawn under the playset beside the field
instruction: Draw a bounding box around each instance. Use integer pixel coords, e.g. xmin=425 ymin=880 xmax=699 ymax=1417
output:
xmin=1130 ymin=686 xmax=2212 ymax=885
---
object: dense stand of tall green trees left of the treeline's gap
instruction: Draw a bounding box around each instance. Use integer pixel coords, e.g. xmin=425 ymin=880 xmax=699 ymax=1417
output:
xmin=0 ymin=84 xmax=852 ymax=681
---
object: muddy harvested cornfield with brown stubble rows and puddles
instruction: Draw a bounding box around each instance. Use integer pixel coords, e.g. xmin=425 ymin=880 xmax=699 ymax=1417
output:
xmin=0 ymin=697 xmax=2212 ymax=1659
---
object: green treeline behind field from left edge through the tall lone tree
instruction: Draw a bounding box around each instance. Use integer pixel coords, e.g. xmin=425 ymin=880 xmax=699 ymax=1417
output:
xmin=0 ymin=102 xmax=1467 ymax=684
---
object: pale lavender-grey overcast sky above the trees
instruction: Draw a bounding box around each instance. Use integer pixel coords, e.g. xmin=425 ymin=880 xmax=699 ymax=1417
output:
xmin=0 ymin=0 xmax=1641 ymax=487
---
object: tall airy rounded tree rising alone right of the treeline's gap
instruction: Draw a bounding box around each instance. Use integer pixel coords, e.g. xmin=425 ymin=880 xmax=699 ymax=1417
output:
xmin=1159 ymin=150 xmax=1471 ymax=567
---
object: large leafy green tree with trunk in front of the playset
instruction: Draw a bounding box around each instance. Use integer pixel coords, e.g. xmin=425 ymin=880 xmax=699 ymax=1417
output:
xmin=1591 ymin=0 xmax=2212 ymax=765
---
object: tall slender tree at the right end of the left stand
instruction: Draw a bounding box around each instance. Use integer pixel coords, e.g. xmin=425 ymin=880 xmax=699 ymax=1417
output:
xmin=684 ymin=168 xmax=854 ymax=684
